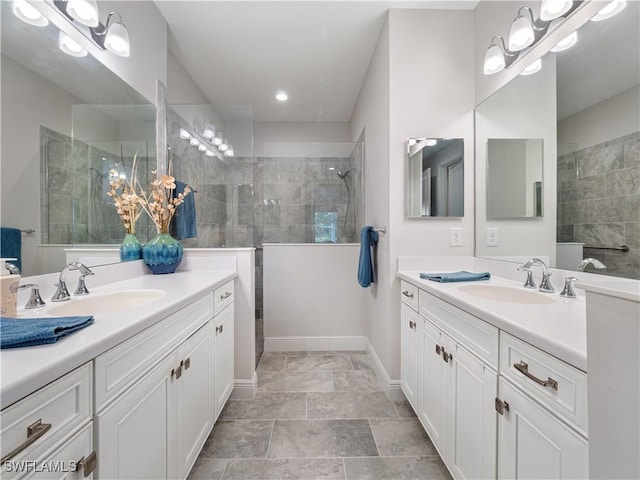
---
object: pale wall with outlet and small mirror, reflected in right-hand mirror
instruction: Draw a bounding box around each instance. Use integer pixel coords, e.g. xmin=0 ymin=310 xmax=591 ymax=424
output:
xmin=475 ymin=56 xmax=557 ymax=265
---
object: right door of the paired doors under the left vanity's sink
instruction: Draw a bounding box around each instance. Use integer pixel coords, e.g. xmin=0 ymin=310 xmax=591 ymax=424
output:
xmin=175 ymin=324 xmax=213 ymax=478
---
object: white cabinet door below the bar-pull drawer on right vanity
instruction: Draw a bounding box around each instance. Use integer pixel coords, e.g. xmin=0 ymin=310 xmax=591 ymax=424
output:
xmin=498 ymin=378 xmax=589 ymax=480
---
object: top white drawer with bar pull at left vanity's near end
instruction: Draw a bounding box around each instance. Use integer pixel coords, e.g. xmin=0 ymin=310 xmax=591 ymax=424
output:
xmin=0 ymin=363 xmax=93 ymax=478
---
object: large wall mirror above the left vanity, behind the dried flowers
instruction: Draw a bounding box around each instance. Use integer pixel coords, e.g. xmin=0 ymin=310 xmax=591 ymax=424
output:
xmin=0 ymin=2 xmax=156 ymax=276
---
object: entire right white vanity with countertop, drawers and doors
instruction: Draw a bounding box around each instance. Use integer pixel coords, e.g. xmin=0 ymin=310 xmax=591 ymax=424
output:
xmin=398 ymin=259 xmax=589 ymax=479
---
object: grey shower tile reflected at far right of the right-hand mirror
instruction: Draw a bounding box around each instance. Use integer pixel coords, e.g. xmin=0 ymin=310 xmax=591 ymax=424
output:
xmin=557 ymin=132 xmax=640 ymax=279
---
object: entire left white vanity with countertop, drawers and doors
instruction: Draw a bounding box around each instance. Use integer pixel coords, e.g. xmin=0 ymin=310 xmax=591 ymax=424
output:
xmin=1 ymin=271 xmax=237 ymax=479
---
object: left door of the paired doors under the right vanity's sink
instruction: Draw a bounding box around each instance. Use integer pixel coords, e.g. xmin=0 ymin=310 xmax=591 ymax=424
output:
xmin=418 ymin=317 xmax=447 ymax=457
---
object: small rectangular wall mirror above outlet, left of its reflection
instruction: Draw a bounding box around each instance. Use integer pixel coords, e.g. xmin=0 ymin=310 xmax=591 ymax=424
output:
xmin=407 ymin=137 xmax=464 ymax=218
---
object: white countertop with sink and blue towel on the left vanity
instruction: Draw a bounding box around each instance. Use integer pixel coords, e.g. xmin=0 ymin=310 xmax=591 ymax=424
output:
xmin=0 ymin=271 xmax=237 ymax=408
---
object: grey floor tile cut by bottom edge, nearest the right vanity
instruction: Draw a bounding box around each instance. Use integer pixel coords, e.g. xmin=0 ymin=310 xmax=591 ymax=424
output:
xmin=344 ymin=456 xmax=452 ymax=480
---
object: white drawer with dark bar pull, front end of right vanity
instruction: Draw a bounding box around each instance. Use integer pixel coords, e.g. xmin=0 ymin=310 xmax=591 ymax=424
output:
xmin=500 ymin=332 xmax=587 ymax=436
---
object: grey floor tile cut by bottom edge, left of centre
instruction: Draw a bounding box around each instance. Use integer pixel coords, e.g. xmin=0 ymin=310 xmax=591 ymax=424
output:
xmin=224 ymin=458 xmax=345 ymax=480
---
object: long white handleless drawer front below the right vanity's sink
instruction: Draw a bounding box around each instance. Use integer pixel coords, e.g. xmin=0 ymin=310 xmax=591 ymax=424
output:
xmin=419 ymin=290 xmax=500 ymax=370
